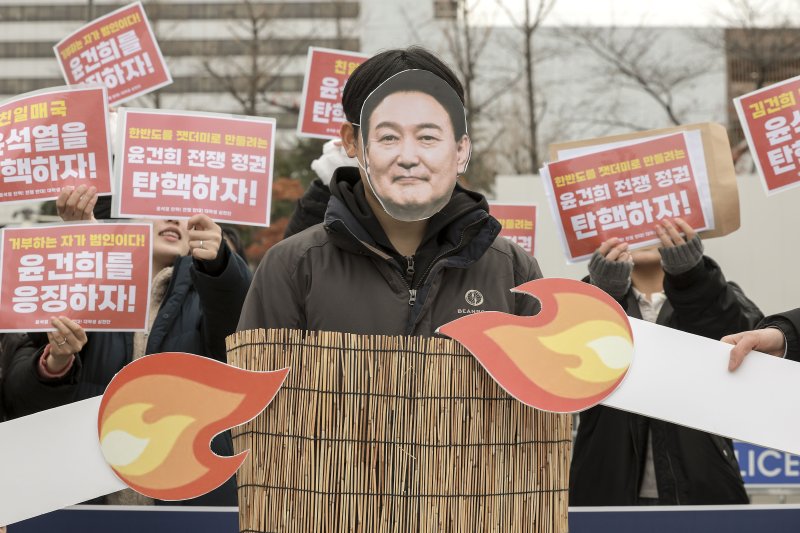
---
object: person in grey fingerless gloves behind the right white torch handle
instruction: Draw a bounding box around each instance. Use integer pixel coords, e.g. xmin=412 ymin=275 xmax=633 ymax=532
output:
xmin=569 ymin=218 xmax=762 ymax=506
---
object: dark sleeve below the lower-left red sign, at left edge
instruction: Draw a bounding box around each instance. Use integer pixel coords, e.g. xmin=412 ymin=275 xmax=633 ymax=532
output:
xmin=2 ymin=334 xmax=83 ymax=418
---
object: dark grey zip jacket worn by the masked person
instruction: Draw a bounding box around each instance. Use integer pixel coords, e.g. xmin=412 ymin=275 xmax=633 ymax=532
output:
xmin=239 ymin=174 xmax=541 ymax=336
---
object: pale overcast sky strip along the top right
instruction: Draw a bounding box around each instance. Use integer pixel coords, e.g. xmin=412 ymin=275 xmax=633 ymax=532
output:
xmin=478 ymin=0 xmax=800 ymax=27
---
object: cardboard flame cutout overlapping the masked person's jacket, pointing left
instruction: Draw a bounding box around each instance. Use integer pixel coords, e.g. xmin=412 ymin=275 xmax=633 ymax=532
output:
xmin=438 ymin=278 xmax=633 ymax=413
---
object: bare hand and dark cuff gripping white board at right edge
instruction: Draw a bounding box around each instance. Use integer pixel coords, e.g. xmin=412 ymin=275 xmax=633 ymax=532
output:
xmin=722 ymin=308 xmax=800 ymax=371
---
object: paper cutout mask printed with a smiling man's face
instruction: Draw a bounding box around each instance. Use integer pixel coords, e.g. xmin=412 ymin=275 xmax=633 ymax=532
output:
xmin=360 ymin=70 xmax=472 ymax=222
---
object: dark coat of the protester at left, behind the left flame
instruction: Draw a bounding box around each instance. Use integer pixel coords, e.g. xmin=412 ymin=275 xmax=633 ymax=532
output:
xmin=3 ymin=247 xmax=250 ymax=505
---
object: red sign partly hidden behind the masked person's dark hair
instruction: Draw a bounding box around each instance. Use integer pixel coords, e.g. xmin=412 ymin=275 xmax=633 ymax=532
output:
xmin=297 ymin=46 xmax=369 ymax=139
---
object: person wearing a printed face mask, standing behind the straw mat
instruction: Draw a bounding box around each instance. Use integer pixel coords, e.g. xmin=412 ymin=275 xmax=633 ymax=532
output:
xmin=238 ymin=48 xmax=541 ymax=336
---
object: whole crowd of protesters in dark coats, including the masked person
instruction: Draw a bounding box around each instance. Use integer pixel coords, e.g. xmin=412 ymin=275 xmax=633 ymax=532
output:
xmin=0 ymin=48 xmax=800 ymax=516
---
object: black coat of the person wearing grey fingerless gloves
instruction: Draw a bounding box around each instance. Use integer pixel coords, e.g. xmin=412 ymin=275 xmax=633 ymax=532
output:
xmin=569 ymin=257 xmax=762 ymax=506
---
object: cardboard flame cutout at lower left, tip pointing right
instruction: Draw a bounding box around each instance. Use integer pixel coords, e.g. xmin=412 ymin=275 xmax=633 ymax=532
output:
xmin=97 ymin=353 xmax=289 ymax=500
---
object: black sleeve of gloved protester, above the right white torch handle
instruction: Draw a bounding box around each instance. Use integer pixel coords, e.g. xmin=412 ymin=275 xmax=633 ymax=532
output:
xmin=664 ymin=256 xmax=764 ymax=339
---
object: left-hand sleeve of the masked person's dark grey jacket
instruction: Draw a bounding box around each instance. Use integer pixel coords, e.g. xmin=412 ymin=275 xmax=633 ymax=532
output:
xmin=237 ymin=241 xmax=306 ymax=331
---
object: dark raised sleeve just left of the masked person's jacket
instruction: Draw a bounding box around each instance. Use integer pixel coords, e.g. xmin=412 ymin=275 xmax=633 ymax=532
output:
xmin=191 ymin=242 xmax=252 ymax=362
